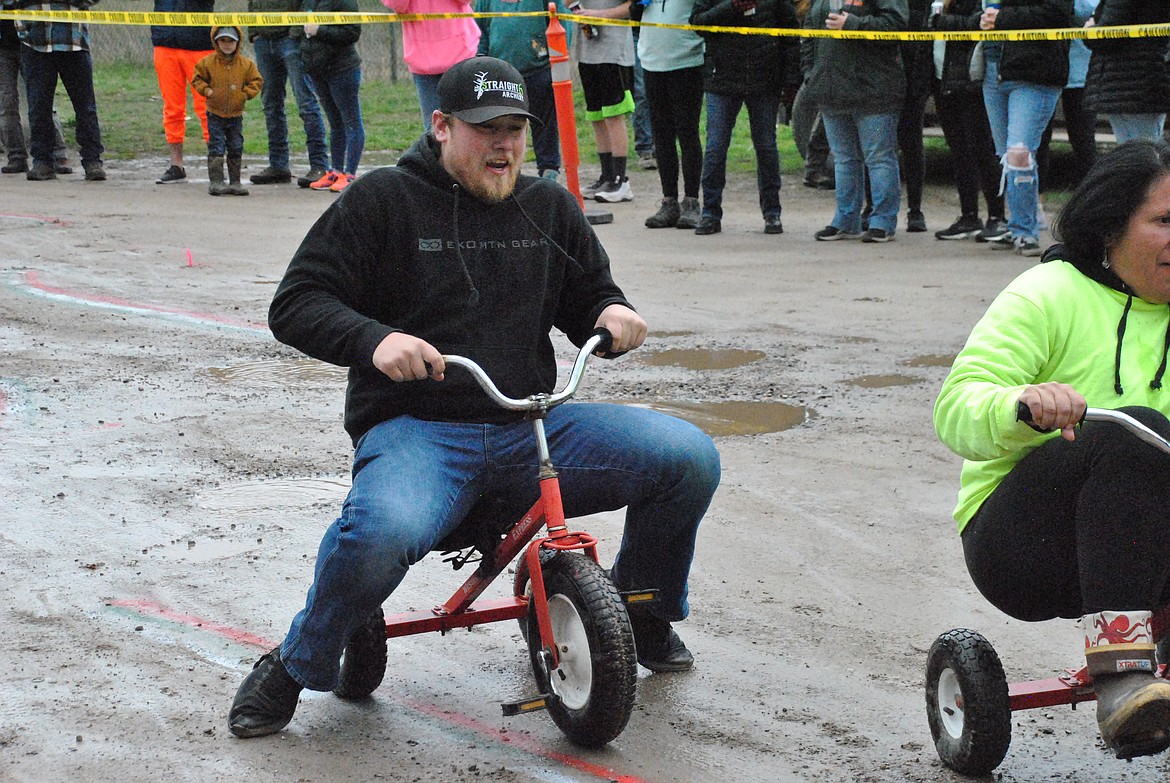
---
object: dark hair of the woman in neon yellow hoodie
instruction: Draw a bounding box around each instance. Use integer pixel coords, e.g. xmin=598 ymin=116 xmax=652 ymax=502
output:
xmin=1052 ymin=139 xmax=1170 ymax=270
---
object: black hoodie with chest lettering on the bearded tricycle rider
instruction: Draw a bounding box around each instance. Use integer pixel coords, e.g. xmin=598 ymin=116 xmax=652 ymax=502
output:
xmin=268 ymin=136 xmax=629 ymax=442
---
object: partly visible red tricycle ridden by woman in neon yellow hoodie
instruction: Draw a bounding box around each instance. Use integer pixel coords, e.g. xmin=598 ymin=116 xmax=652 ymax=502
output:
xmin=927 ymin=406 xmax=1170 ymax=775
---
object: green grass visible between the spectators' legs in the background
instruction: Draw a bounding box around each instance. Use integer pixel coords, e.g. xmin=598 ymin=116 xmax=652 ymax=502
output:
xmin=68 ymin=62 xmax=801 ymax=174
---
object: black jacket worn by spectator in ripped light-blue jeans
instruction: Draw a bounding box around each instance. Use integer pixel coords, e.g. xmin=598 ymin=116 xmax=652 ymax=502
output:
xmin=935 ymin=0 xmax=1076 ymax=88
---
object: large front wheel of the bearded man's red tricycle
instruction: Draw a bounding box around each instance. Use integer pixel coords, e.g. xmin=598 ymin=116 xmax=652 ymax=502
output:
xmin=528 ymin=552 xmax=638 ymax=748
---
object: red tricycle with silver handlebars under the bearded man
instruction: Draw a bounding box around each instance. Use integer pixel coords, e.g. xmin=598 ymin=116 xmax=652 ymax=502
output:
xmin=325 ymin=329 xmax=656 ymax=747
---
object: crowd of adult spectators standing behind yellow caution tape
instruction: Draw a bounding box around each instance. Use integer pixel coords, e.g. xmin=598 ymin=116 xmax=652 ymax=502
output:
xmin=0 ymin=0 xmax=1170 ymax=241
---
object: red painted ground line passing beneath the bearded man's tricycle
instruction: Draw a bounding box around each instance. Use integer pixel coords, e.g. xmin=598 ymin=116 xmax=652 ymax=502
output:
xmin=108 ymin=598 xmax=648 ymax=783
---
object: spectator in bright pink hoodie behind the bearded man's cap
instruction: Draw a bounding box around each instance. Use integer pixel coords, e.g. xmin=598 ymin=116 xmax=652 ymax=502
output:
xmin=381 ymin=0 xmax=480 ymax=131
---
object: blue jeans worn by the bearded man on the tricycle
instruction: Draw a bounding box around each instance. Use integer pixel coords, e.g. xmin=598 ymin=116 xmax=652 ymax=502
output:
xmin=281 ymin=403 xmax=720 ymax=691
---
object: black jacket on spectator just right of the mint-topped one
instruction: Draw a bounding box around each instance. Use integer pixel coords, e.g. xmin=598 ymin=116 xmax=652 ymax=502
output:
xmin=690 ymin=0 xmax=800 ymax=95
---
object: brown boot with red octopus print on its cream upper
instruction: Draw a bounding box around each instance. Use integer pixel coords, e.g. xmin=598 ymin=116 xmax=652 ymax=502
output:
xmin=1082 ymin=611 xmax=1170 ymax=758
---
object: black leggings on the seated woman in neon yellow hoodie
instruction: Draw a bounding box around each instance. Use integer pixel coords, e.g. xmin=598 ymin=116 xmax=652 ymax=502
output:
xmin=963 ymin=407 xmax=1170 ymax=620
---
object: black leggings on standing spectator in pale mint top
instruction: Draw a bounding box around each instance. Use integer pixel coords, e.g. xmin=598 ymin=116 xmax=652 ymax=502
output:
xmin=642 ymin=66 xmax=703 ymax=199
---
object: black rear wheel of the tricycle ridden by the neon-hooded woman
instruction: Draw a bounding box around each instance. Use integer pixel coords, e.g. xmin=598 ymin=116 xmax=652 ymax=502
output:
xmin=927 ymin=629 xmax=1012 ymax=775
